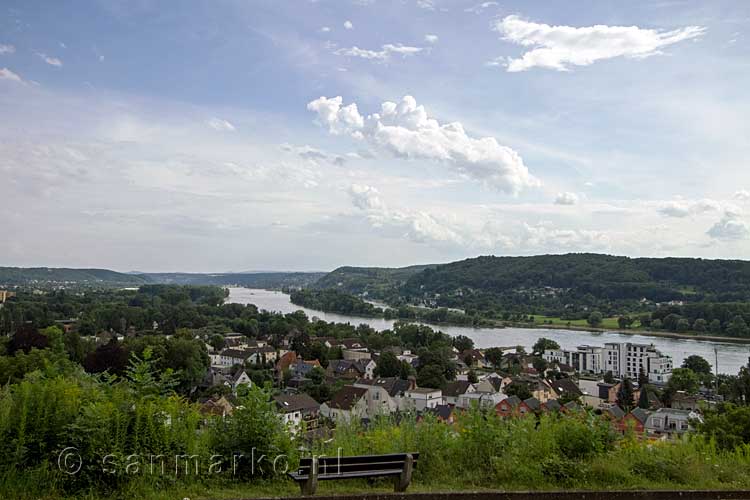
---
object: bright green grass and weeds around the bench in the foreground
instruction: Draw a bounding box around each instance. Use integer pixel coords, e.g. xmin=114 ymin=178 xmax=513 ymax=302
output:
xmin=5 ymin=410 xmax=750 ymax=500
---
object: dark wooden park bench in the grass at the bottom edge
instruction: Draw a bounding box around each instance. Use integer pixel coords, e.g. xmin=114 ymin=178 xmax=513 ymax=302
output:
xmin=289 ymin=453 xmax=419 ymax=495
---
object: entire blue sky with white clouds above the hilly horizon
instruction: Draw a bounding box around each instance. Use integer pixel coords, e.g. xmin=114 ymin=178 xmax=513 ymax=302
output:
xmin=0 ymin=0 xmax=750 ymax=272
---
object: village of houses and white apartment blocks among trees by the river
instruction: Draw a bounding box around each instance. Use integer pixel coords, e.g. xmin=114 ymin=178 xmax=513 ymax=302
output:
xmin=195 ymin=328 xmax=714 ymax=439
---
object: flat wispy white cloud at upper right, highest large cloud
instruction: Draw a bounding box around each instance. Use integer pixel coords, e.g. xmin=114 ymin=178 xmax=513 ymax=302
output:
xmin=494 ymin=15 xmax=706 ymax=72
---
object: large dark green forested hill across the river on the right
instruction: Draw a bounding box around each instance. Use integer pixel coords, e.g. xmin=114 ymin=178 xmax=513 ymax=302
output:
xmin=316 ymin=254 xmax=750 ymax=308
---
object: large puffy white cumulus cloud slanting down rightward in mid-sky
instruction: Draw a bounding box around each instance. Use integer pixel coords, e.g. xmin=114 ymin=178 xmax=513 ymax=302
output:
xmin=307 ymin=96 xmax=540 ymax=194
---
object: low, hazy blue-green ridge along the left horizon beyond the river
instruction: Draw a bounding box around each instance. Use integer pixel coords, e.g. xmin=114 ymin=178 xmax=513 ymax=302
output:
xmin=0 ymin=267 xmax=325 ymax=288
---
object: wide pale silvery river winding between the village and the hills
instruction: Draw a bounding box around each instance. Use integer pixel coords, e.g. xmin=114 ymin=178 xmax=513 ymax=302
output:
xmin=228 ymin=288 xmax=750 ymax=375
